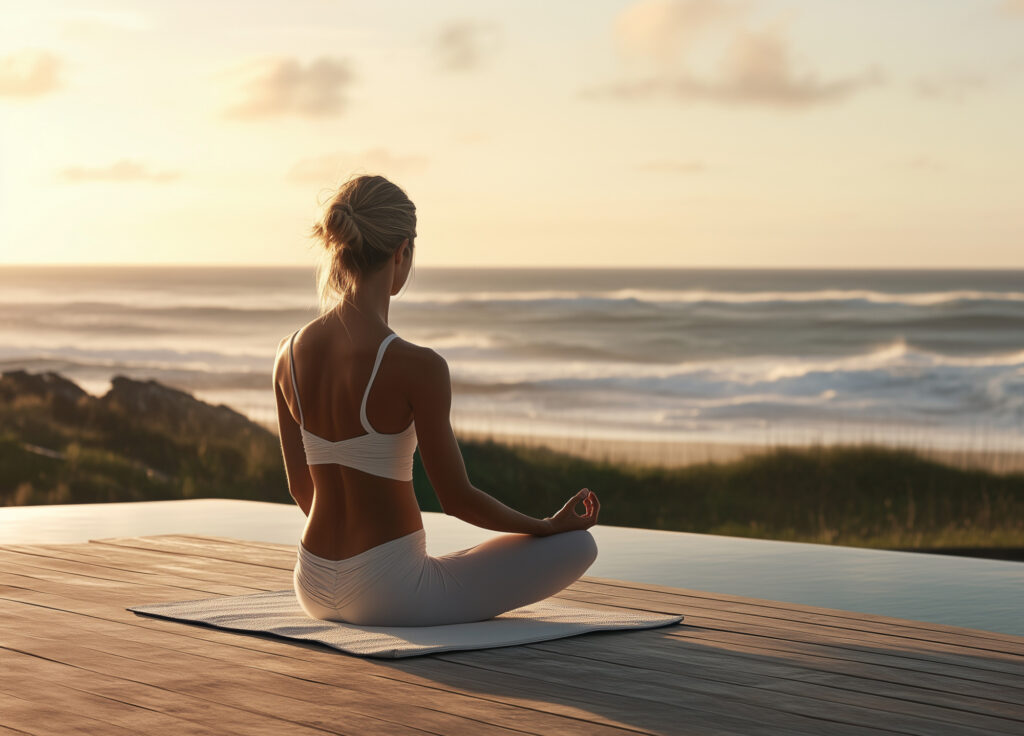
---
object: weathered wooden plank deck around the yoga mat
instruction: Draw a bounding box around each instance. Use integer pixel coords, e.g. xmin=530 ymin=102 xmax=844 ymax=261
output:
xmin=0 ymin=534 xmax=1024 ymax=736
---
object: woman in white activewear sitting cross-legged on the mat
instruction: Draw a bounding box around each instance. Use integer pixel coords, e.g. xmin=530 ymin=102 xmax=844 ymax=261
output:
xmin=273 ymin=176 xmax=600 ymax=626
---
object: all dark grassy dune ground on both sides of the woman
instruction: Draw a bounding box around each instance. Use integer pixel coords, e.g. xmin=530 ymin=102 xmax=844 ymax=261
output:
xmin=0 ymin=375 xmax=1024 ymax=550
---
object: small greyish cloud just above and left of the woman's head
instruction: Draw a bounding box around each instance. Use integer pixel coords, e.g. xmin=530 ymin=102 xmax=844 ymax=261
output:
xmin=225 ymin=56 xmax=353 ymax=119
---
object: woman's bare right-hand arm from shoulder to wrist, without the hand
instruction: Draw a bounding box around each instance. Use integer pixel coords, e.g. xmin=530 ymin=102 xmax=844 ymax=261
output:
xmin=410 ymin=349 xmax=553 ymax=536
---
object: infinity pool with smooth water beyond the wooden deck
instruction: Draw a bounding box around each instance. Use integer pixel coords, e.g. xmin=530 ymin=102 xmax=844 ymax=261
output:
xmin=0 ymin=499 xmax=1024 ymax=636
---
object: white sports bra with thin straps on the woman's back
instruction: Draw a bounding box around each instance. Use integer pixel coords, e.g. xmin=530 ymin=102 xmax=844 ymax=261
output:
xmin=288 ymin=331 xmax=417 ymax=480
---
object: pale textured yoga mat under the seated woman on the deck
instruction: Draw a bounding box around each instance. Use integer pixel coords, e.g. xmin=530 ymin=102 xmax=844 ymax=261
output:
xmin=127 ymin=589 xmax=683 ymax=658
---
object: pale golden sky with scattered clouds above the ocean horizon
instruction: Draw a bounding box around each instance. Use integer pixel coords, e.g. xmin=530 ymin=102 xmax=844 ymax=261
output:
xmin=0 ymin=0 xmax=1024 ymax=268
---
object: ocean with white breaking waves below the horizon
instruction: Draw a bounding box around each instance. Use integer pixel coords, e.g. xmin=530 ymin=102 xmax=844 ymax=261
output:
xmin=0 ymin=266 xmax=1024 ymax=450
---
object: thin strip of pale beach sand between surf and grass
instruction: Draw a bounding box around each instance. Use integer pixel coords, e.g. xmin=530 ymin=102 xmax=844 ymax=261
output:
xmin=456 ymin=430 xmax=1024 ymax=473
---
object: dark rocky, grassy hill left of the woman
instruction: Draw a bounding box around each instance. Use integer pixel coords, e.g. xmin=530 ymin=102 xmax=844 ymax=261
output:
xmin=0 ymin=371 xmax=289 ymax=506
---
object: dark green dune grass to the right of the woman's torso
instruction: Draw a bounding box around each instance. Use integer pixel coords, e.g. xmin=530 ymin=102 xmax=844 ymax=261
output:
xmin=414 ymin=441 xmax=1024 ymax=549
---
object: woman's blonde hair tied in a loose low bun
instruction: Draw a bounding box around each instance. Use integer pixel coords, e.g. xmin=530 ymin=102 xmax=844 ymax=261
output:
xmin=311 ymin=176 xmax=416 ymax=316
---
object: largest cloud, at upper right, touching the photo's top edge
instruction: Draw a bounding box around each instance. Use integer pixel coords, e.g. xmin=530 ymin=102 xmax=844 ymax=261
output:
xmin=582 ymin=0 xmax=882 ymax=107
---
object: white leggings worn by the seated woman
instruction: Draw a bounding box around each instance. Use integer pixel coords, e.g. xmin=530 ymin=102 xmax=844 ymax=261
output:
xmin=292 ymin=529 xmax=597 ymax=626
